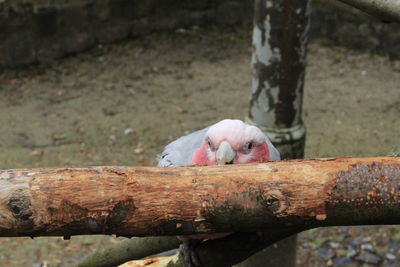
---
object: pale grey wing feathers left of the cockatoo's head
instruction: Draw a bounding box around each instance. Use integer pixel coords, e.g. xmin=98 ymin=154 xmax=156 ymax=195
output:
xmin=157 ymin=127 xmax=209 ymax=167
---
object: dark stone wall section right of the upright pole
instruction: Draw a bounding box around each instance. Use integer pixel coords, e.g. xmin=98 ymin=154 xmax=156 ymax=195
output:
xmin=311 ymin=0 xmax=400 ymax=59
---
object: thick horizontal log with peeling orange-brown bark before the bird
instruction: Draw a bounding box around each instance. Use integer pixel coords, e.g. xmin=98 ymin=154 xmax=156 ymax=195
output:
xmin=0 ymin=157 xmax=400 ymax=237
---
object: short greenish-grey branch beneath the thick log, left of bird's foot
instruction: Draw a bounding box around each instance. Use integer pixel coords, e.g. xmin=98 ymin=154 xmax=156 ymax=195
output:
xmin=75 ymin=236 xmax=181 ymax=267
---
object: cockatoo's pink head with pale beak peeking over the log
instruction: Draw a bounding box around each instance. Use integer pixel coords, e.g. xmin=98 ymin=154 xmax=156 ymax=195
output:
xmin=192 ymin=120 xmax=270 ymax=165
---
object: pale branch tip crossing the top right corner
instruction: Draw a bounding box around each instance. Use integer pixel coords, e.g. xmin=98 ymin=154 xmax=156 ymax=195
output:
xmin=340 ymin=0 xmax=400 ymax=23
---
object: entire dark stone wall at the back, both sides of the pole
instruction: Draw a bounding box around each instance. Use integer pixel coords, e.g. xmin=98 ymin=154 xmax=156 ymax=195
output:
xmin=0 ymin=0 xmax=400 ymax=67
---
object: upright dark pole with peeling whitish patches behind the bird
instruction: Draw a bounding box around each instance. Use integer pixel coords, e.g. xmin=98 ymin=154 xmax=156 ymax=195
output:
xmin=238 ymin=0 xmax=311 ymax=267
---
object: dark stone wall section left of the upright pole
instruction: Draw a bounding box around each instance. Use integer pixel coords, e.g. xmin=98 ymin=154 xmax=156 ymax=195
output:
xmin=0 ymin=0 xmax=252 ymax=66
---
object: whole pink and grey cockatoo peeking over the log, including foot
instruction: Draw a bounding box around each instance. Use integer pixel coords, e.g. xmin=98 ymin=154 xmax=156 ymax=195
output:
xmin=157 ymin=119 xmax=280 ymax=266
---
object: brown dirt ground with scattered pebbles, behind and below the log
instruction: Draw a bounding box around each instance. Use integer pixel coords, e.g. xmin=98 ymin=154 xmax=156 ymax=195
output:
xmin=0 ymin=25 xmax=400 ymax=266
